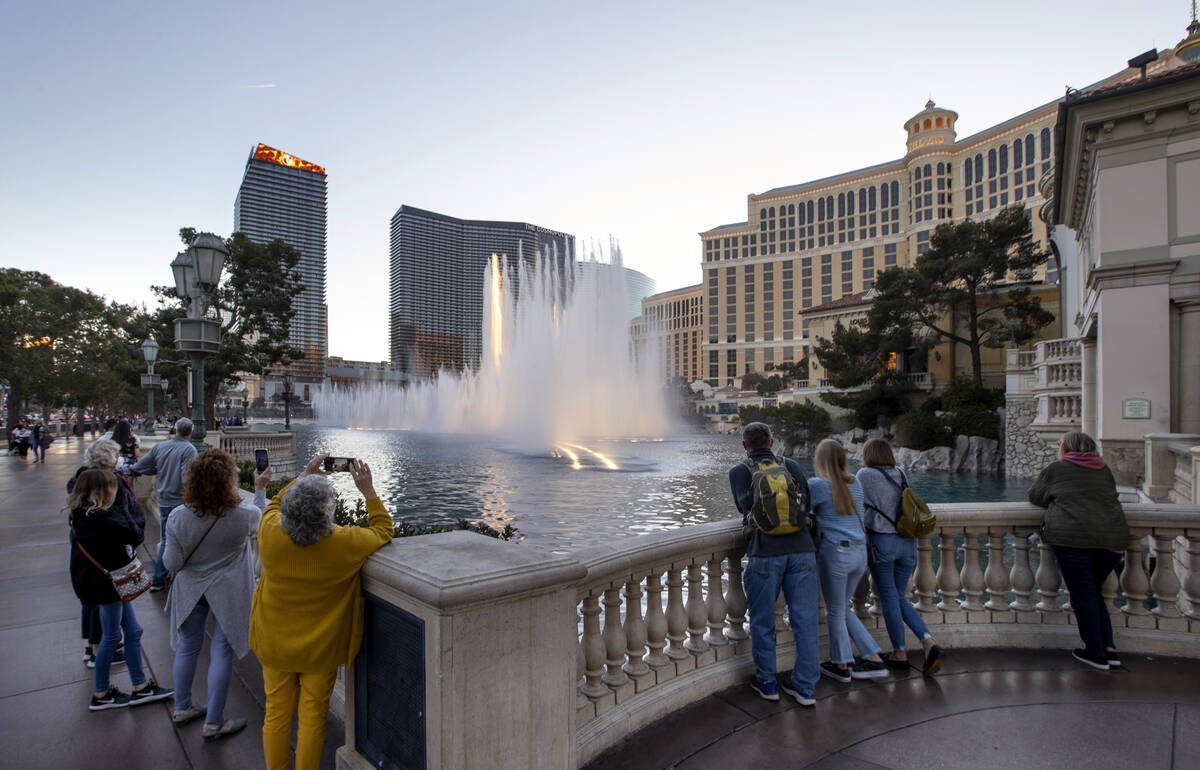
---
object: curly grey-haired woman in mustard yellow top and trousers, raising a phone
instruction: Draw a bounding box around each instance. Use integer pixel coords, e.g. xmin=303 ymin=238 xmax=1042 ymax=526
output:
xmin=250 ymin=456 xmax=392 ymax=770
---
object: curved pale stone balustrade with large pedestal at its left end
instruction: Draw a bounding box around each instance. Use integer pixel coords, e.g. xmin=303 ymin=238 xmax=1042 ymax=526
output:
xmin=338 ymin=503 xmax=1200 ymax=768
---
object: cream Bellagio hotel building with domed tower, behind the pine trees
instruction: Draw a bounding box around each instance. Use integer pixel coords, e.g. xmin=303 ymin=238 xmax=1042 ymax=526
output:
xmin=700 ymin=94 xmax=1058 ymax=386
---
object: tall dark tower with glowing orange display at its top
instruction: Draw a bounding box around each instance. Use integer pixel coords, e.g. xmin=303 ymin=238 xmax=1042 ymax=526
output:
xmin=233 ymin=144 xmax=329 ymax=381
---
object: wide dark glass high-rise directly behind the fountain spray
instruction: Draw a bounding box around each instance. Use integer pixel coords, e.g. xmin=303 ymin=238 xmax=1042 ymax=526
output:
xmin=388 ymin=206 xmax=575 ymax=377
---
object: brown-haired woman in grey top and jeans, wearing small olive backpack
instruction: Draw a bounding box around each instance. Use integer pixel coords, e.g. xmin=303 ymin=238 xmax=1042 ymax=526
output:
xmin=858 ymin=439 xmax=943 ymax=674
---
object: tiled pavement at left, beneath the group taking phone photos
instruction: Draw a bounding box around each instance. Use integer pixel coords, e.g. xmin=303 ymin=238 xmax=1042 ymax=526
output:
xmin=0 ymin=438 xmax=343 ymax=770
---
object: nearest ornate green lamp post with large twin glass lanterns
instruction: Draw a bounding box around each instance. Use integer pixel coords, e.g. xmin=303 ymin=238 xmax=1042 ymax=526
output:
xmin=170 ymin=233 xmax=229 ymax=450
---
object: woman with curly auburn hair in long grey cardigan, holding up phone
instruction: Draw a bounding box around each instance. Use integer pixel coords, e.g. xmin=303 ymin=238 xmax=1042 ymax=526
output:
xmin=162 ymin=449 xmax=271 ymax=740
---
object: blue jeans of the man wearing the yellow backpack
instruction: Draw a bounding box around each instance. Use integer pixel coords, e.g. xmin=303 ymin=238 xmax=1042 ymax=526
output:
xmin=743 ymin=553 xmax=821 ymax=698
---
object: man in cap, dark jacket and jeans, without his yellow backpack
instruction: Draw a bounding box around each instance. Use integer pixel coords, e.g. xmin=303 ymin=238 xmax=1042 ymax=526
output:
xmin=730 ymin=422 xmax=821 ymax=706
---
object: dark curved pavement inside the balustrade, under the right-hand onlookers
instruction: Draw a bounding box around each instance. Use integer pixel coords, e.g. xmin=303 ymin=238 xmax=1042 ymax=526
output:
xmin=587 ymin=649 xmax=1200 ymax=770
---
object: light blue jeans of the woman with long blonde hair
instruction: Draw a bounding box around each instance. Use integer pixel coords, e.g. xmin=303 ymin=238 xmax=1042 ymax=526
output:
xmin=817 ymin=540 xmax=880 ymax=663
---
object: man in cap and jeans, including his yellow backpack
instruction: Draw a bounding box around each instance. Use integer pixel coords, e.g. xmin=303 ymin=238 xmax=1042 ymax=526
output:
xmin=730 ymin=422 xmax=821 ymax=706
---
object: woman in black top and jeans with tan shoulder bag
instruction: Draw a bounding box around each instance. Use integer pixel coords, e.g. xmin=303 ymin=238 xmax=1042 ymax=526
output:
xmin=64 ymin=469 xmax=173 ymax=711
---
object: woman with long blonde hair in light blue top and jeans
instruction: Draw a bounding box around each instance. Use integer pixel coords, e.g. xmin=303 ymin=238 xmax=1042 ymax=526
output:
xmin=809 ymin=439 xmax=888 ymax=682
